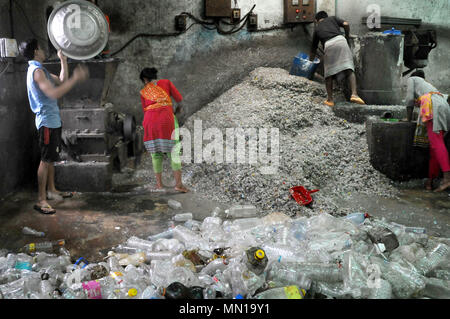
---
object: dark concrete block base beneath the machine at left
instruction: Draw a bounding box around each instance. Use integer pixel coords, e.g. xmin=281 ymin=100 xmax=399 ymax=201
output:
xmin=55 ymin=161 xmax=112 ymax=192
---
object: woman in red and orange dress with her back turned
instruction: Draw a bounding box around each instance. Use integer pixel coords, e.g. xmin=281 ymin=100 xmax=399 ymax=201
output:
xmin=140 ymin=68 xmax=189 ymax=193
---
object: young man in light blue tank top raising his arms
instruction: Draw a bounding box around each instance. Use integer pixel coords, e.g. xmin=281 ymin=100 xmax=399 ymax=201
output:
xmin=20 ymin=39 xmax=89 ymax=214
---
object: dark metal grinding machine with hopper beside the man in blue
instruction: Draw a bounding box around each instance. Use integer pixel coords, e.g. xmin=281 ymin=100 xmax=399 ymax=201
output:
xmin=45 ymin=58 xmax=144 ymax=192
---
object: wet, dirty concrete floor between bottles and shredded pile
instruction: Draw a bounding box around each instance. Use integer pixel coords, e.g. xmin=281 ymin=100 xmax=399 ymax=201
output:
xmin=0 ymin=154 xmax=450 ymax=262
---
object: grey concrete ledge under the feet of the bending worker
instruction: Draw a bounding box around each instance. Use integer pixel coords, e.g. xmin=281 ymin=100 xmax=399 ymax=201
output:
xmin=333 ymin=103 xmax=406 ymax=124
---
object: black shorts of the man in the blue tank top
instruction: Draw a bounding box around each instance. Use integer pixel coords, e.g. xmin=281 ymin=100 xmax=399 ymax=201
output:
xmin=39 ymin=126 xmax=62 ymax=163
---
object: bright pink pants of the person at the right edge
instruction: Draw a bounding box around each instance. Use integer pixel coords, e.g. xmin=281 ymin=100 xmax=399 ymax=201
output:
xmin=426 ymin=120 xmax=450 ymax=178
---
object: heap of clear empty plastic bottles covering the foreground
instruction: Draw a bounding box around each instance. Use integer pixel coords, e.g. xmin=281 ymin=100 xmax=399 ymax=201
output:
xmin=0 ymin=202 xmax=450 ymax=299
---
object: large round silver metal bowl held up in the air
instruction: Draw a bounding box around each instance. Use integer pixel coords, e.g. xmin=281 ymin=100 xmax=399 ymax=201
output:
xmin=47 ymin=0 xmax=109 ymax=60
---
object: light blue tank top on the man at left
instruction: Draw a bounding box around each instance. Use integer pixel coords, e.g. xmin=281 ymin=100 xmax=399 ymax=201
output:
xmin=27 ymin=60 xmax=61 ymax=130
